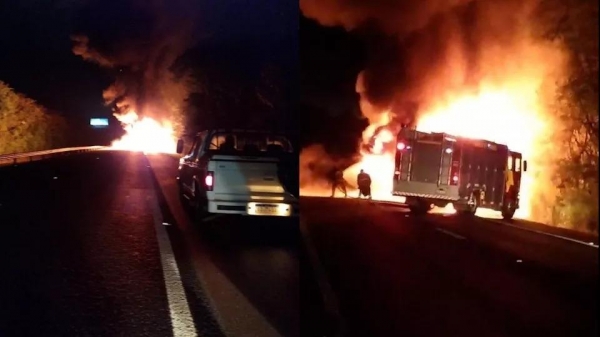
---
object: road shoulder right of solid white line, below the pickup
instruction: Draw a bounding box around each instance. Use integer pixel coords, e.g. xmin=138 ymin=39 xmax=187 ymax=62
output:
xmin=149 ymin=155 xmax=326 ymax=336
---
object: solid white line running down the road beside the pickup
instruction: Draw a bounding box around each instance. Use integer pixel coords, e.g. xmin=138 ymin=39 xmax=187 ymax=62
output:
xmin=149 ymin=191 xmax=198 ymax=337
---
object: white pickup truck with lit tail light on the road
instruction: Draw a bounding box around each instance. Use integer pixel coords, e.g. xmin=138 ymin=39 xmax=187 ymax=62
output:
xmin=177 ymin=130 xmax=299 ymax=218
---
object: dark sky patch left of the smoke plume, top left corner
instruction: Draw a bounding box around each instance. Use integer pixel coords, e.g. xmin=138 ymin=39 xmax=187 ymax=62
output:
xmin=0 ymin=0 xmax=111 ymax=118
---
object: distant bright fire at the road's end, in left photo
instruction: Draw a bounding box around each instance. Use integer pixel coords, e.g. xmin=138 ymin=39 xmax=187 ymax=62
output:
xmin=111 ymin=110 xmax=177 ymax=154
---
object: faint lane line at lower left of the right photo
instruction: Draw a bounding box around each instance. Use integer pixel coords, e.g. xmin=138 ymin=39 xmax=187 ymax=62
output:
xmin=300 ymin=220 xmax=346 ymax=336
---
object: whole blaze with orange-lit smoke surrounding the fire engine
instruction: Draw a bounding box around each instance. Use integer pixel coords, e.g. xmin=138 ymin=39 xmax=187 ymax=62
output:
xmin=300 ymin=0 xmax=565 ymax=220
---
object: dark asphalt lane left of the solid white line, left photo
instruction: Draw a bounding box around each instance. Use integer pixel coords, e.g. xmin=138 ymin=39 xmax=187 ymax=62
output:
xmin=0 ymin=152 xmax=190 ymax=336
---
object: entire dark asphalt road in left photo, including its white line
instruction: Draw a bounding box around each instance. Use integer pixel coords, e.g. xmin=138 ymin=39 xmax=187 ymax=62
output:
xmin=0 ymin=151 xmax=323 ymax=337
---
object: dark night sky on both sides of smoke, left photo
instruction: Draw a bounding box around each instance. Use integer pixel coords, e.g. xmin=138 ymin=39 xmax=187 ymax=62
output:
xmin=0 ymin=0 xmax=299 ymax=127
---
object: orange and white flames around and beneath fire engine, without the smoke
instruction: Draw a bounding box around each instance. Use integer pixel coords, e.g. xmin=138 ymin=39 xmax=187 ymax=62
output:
xmin=301 ymin=40 xmax=564 ymax=222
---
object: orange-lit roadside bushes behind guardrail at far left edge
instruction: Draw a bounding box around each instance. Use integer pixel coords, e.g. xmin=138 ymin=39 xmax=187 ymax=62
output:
xmin=0 ymin=81 xmax=67 ymax=154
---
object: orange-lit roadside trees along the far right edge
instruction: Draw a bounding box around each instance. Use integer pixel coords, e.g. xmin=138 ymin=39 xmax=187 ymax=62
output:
xmin=540 ymin=0 xmax=599 ymax=233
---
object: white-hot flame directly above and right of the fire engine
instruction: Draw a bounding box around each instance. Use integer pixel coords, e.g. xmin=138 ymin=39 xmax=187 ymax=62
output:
xmin=417 ymin=82 xmax=548 ymax=218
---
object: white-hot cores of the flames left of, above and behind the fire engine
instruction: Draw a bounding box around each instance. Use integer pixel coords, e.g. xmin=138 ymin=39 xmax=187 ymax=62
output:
xmin=345 ymin=81 xmax=549 ymax=218
